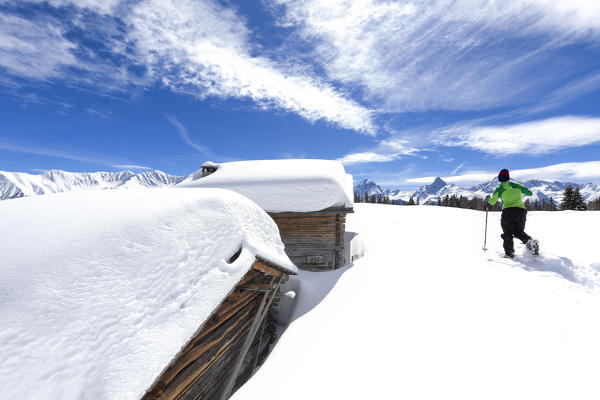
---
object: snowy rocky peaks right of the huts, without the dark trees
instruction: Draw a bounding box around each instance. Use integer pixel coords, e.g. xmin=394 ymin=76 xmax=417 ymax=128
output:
xmin=354 ymin=178 xmax=600 ymax=204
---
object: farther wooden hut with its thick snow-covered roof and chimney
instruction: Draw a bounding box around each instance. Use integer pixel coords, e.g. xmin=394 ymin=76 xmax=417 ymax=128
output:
xmin=177 ymin=160 xmax=354 ymax=270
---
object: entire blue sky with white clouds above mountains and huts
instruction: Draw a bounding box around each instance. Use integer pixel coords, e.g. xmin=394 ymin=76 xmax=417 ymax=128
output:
xmin=0 ymin=0 xmax=600 ymax=189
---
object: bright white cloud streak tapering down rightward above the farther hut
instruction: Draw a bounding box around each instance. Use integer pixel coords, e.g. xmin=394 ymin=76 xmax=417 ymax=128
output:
xmin=128 ymin=0 xmax=376 ymax=134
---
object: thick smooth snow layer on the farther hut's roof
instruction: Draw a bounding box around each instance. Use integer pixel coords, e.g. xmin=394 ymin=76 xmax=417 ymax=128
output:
xmin=178 ymin=160 xmax=354 ymax=212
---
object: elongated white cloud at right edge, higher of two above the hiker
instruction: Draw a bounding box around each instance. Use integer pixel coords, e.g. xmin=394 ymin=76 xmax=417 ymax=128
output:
xmin=433 ymin=116 xmax=600 ymax=155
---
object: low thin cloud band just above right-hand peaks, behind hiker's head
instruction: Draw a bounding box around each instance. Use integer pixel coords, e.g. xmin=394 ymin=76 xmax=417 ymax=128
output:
xmin=406 ymin=161 xmax=600 ymax=186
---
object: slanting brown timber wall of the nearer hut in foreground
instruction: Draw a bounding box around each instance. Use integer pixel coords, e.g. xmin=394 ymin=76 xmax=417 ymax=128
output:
xmin=143 ymin=260 xmax=288 ymax=400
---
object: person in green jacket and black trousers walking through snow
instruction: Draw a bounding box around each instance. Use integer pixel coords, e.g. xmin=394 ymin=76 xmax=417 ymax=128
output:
xmin=485 ymin=169 xmax=539 ymax=258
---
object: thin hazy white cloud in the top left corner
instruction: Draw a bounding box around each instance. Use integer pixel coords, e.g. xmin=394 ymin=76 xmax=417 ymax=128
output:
xmin=0 ymin=7 xmax=142 ymax=93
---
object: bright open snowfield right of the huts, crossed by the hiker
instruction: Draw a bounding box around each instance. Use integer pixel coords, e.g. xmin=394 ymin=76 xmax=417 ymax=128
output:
xmin=233 ymin=204 xmax=600 ymax=400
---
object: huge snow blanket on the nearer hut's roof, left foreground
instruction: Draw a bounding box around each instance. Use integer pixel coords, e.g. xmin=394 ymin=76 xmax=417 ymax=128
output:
xmin=0 ymin=189 xmax=296 ymax=400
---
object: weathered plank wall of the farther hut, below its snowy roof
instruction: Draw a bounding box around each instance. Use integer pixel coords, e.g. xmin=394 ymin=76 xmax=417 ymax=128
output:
xmin=269 ymin=208 xmax=353 ymax=271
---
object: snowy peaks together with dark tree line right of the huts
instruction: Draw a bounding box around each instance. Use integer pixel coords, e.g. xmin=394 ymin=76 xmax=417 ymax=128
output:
xmin=354 ymin=178 xmax=600 ymax=211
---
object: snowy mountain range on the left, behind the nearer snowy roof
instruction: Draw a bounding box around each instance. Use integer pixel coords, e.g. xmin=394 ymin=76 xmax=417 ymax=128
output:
xmin=0 ymin=170 xmax=185 ymax=200
